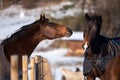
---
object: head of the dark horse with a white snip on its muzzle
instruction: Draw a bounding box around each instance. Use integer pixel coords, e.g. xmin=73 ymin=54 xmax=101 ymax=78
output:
xmin=83 ymin=13 xmax=102 ymax=48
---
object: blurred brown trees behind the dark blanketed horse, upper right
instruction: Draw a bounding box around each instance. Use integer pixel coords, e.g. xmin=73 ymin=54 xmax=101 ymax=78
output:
xmin=83 ymin=0 xmax=120 ymax=37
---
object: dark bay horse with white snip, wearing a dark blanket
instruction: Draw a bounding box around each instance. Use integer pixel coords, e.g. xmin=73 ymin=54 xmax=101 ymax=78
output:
xmin=83 ymin=13 xmax=120 ymax=80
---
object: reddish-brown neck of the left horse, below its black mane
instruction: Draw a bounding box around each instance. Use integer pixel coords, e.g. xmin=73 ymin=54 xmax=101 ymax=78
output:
xmin=2 ymin=21 xmax=45 ymax=60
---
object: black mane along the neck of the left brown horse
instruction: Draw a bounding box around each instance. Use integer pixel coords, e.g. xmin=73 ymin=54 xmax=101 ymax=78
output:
xmin=2 ymin=20 xmax=40 ymax=44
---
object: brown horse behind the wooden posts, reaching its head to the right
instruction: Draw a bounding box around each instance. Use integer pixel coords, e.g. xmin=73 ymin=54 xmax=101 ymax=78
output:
xmin=1 ymin=15 xmax=72 ymax=79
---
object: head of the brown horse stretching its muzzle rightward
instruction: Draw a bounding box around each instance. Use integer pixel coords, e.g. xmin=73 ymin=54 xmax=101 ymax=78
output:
xmin=39 ymin=15 xmax=72 ymax=39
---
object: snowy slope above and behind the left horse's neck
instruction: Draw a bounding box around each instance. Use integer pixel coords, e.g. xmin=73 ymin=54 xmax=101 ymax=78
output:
xmin=0 ymin=2 xmax=81 ymax=39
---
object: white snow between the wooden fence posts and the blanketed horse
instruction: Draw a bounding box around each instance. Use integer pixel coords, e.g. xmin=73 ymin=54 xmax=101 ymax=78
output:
xmin=31 ymin=48 xmax=84 ymax=80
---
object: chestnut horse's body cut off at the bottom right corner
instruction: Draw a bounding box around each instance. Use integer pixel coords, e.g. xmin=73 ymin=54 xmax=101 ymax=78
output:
xmin=102 ymin=56 xmax=120 ymax=80
